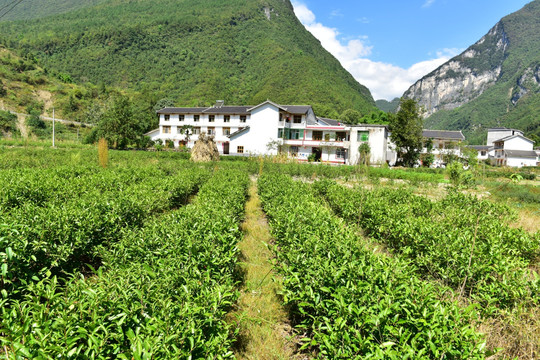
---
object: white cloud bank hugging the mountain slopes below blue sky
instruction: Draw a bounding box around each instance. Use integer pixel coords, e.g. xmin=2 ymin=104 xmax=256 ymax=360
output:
xmin=293 ymin=0 xmax=461 ymax=100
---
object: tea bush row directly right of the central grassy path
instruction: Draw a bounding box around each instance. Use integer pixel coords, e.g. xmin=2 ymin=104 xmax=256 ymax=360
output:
xmin=258 ymin=174 xmax=484 ymax=359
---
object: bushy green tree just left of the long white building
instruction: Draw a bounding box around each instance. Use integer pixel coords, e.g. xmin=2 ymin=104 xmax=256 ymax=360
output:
xmin=98 ymin=95 xmax=143 ymax=149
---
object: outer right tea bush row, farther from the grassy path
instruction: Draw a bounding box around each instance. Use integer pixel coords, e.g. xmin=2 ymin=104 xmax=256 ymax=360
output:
xmin=314 ymin=181 xmax=540 ymax=311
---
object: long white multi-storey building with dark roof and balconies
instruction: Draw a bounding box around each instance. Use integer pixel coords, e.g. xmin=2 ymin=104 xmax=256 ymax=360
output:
xmin=146 ymin=100 xmax=388 ymax=164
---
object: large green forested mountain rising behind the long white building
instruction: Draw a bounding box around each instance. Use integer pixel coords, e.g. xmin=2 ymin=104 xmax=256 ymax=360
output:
xmin=0 ymin=0 xmax=375 ymax=115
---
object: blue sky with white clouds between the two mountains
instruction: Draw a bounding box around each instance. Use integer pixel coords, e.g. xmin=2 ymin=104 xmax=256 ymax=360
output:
xmin=292 ymin=0 xmax=530 ymax=100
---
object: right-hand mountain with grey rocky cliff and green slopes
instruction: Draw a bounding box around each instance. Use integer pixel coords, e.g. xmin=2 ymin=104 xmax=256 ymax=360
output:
xmin=403 ymin=0 xmax=540 ymax=143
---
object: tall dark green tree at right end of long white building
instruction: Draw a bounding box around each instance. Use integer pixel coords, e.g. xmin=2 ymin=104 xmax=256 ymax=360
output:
xmin=389 ymin=98 xmax=424 ymax=167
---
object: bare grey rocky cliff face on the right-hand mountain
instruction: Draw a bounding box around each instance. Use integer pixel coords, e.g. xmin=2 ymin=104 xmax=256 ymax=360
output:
xmin=403 ymin=22 xmax=509 ymax=117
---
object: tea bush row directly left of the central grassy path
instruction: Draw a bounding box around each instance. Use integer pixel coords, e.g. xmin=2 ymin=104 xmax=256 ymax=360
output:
xmin=0 ymin=171 xmax=249 ymax=359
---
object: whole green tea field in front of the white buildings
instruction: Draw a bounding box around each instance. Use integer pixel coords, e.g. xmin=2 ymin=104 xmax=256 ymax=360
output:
xmin=0 ymin=146 xmax=540 ymax=359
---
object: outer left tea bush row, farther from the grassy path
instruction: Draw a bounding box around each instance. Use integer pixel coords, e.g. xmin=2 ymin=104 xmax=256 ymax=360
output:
xmin=0 ymin=169 xmax=209 ymax=296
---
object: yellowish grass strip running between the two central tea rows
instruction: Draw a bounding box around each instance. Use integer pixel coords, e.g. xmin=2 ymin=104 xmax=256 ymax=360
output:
xmin=226 ymin=182 xmax=296 ymax=360
